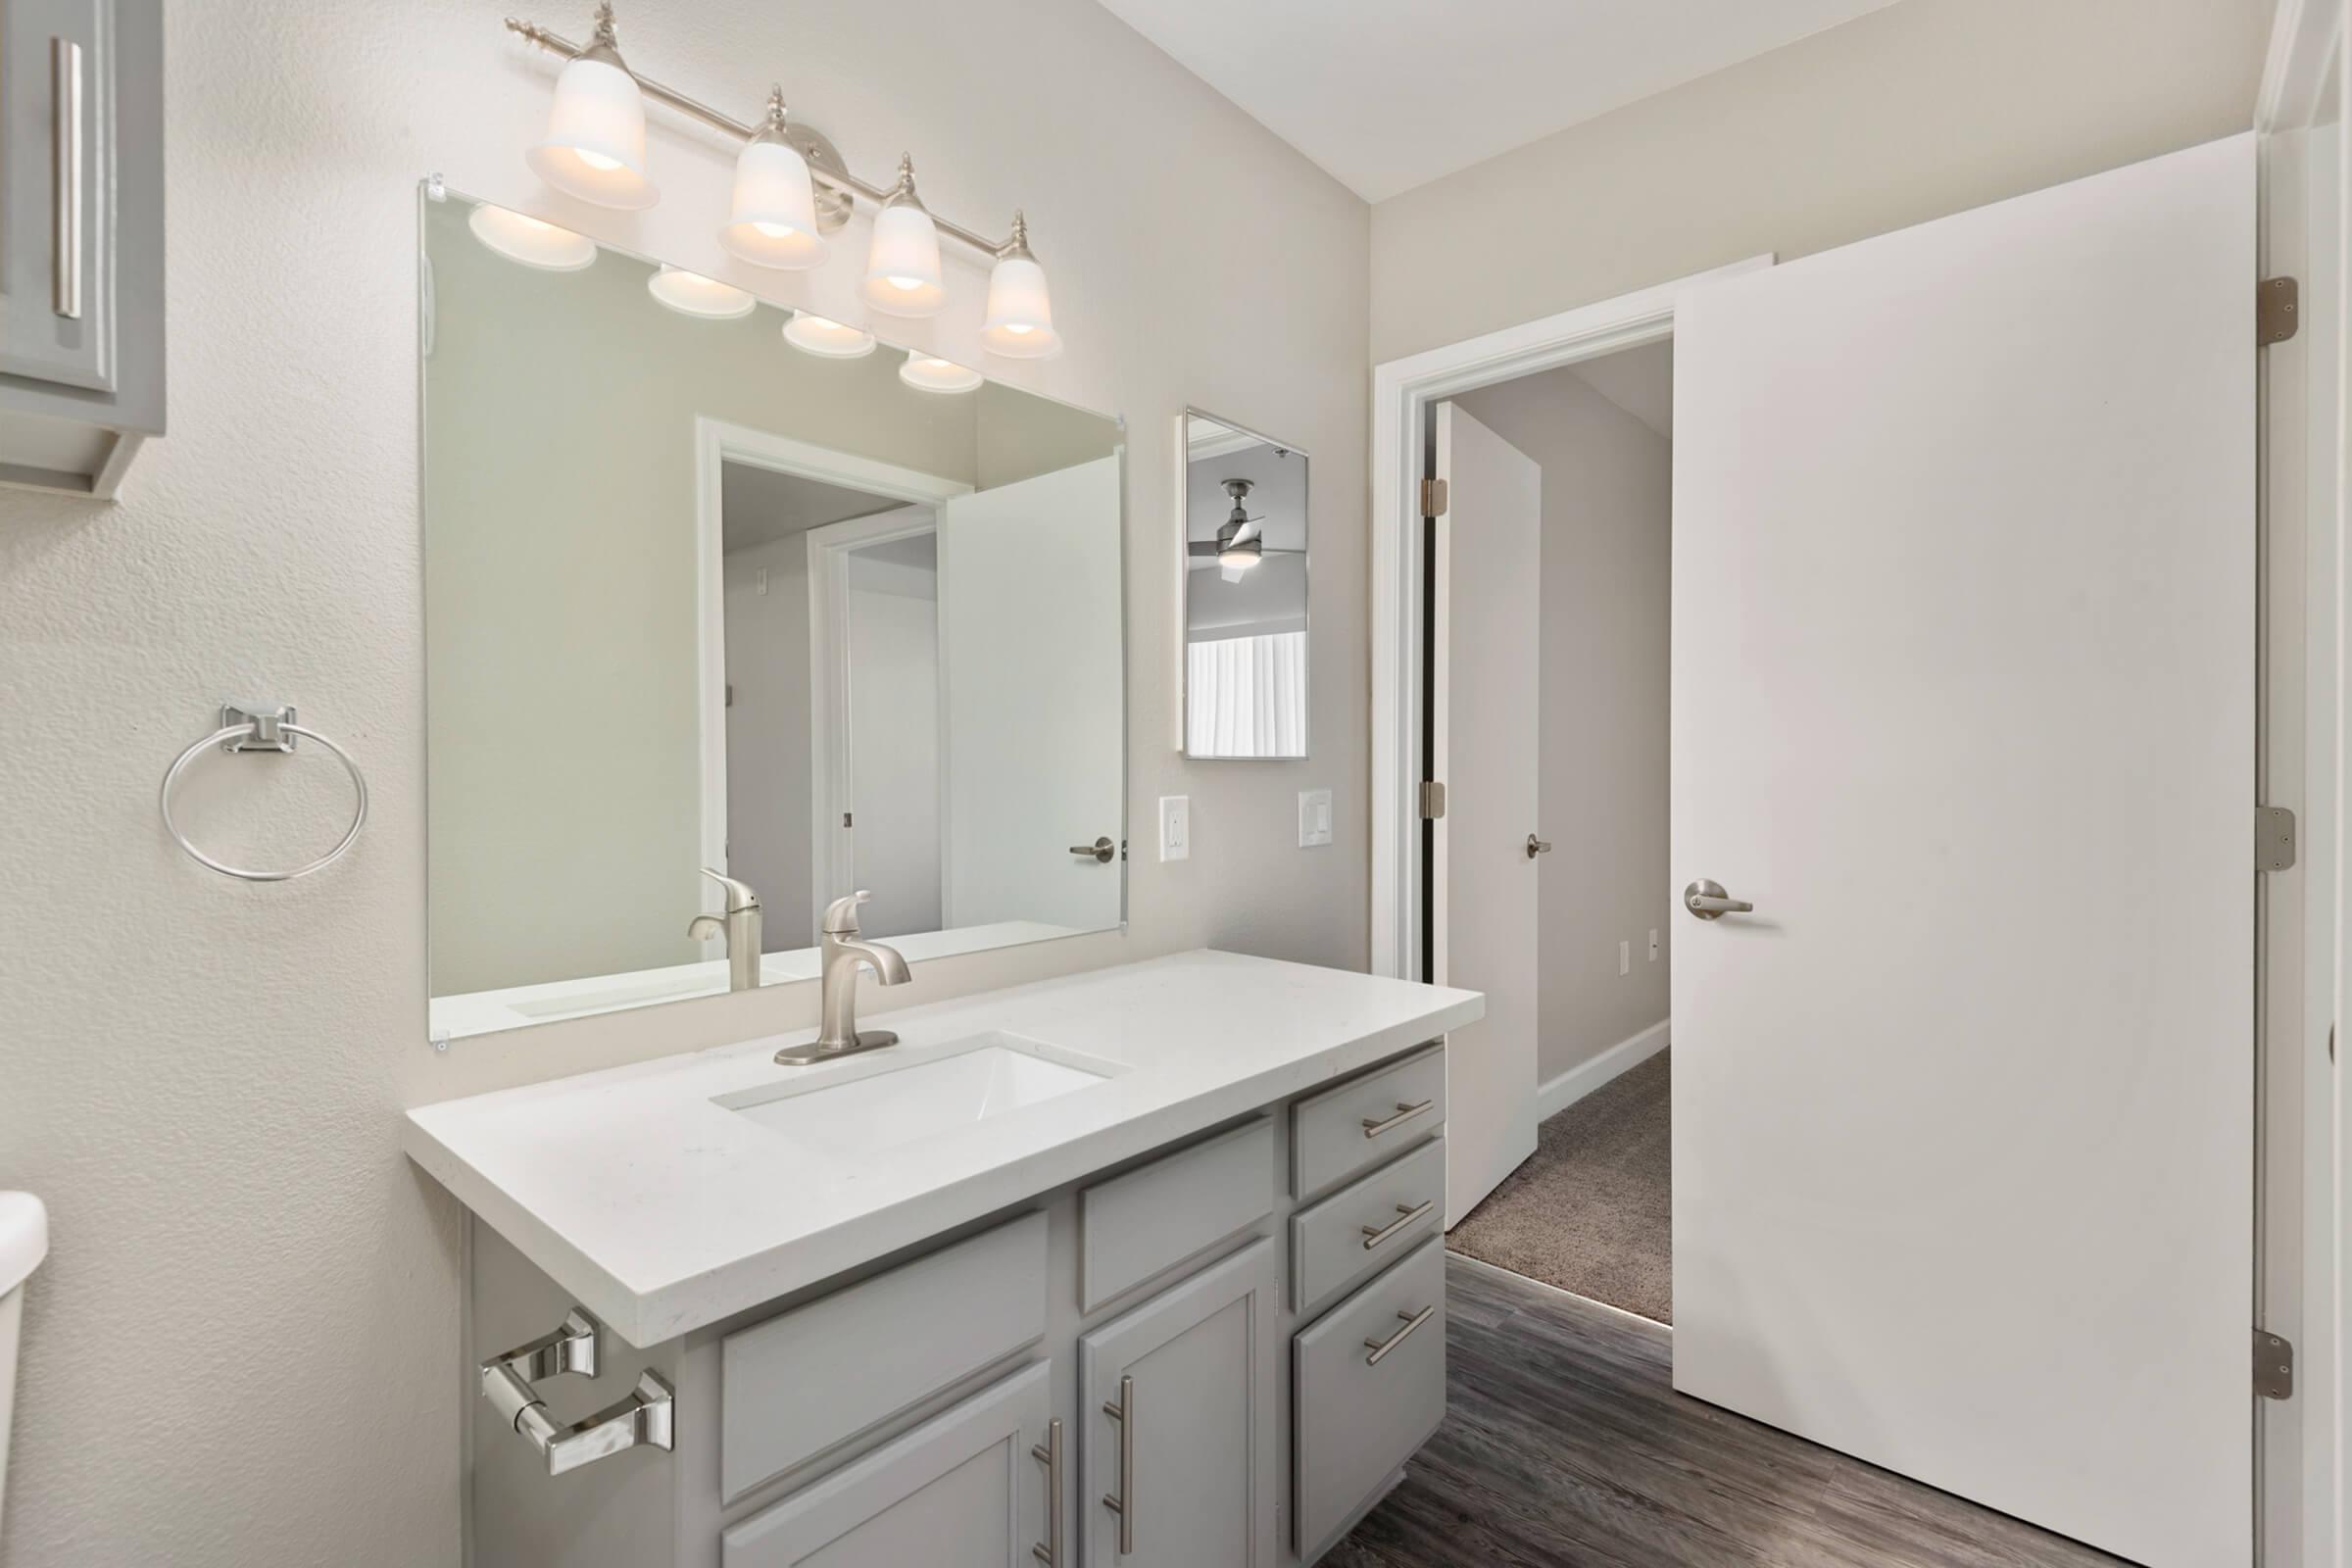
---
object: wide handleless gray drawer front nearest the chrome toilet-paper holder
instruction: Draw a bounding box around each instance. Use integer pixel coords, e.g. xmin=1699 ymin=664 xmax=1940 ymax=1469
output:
xmin=719 ymin=1213 xmax=1047 ymax=1502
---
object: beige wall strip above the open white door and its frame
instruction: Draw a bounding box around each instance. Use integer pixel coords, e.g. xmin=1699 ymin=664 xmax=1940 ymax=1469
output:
xmin=1371 ymin=0 xmax=2272 ymax=362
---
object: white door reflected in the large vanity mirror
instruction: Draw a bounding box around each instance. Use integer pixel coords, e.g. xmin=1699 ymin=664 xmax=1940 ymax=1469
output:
xmin=939 ymin=456 xmax=1127 ymax=931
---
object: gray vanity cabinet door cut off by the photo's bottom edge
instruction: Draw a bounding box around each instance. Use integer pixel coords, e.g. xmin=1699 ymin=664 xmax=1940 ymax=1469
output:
xmin=719 ymin=1363 xmax=1054 ymax=1568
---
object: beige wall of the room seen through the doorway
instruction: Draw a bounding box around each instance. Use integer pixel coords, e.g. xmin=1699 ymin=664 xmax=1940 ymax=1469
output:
xmin=1456 ymin=369 xmax=1675 ymax=1081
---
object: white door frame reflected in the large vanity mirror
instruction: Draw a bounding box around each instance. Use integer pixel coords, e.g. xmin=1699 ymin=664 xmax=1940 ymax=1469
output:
xmin=694 ymin=414 xmax=971 ymax=959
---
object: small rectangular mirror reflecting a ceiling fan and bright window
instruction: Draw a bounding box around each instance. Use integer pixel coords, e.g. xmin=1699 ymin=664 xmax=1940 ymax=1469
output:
xmin=1178 ymin=409 xmax=1307 ymax=760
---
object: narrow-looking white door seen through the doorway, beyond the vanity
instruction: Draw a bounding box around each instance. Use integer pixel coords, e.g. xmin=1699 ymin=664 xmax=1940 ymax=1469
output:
xmin=1430 ymin=402 xmax=1543 ymax=1230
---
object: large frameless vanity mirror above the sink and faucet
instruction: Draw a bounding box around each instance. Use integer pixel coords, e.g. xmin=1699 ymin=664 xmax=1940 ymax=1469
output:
xmin=421 ymin=193 xmax=1127 ymax=1037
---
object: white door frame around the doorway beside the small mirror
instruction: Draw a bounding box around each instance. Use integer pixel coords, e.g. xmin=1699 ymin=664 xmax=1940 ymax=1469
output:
xmin=1371 ymin=254 xmax=1774 ymax=980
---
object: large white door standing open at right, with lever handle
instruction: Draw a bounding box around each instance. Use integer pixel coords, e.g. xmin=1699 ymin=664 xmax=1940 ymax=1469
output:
xmin=1672 ymin=136 xmax=2256 ymax=1568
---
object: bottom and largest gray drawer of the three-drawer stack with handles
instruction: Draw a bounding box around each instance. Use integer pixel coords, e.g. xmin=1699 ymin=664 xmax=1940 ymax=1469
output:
xmin=1292 ymin=1237 xmax=1446 ymax=1561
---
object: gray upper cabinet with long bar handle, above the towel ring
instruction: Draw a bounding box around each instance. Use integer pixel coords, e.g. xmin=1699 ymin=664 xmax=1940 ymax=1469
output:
xmin=0 ymin=0 xmax=165 ymax=499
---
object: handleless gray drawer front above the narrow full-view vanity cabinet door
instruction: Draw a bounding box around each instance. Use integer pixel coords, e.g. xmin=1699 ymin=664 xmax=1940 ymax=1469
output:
xmin=1077 ymin=1116 xmax=1275 ymax=1312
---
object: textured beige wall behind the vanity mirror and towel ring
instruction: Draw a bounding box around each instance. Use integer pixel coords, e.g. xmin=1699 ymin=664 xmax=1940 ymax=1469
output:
xmin=0 ymin=0 xmax=1369 ymax=1568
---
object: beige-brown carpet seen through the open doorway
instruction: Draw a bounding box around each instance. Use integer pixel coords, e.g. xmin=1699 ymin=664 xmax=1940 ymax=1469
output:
xmin=1446 ymin=1051 xmax=1675 ymax=1324
